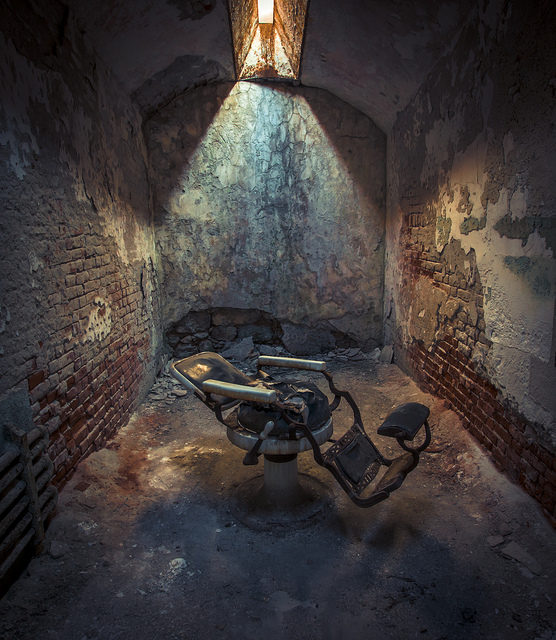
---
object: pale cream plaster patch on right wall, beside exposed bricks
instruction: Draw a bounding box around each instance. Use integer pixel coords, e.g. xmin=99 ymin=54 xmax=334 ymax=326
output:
xmin=428 ymin=131 xmax=554 ymax=424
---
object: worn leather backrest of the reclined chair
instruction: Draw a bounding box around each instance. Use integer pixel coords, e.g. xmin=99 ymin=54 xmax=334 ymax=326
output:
xmin=171 ymin=351 xmax=257 ymax=406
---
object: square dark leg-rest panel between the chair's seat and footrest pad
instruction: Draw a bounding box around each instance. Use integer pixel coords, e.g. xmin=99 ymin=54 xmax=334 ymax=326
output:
xmin=323 ymin=425 xmax=382 ymax=495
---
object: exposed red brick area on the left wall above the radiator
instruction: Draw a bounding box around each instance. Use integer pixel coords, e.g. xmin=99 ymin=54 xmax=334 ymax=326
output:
xmin=23 ymin=228 xmax=152 ymax=484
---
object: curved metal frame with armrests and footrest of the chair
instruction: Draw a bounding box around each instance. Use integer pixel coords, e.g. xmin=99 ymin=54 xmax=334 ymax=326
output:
xmin=170 ymin=352 xmax=431 ymax=507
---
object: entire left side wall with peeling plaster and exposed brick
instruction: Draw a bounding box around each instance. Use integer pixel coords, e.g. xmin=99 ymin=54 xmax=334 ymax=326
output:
xmin=0 ymin=2 xmax=160 ymax=483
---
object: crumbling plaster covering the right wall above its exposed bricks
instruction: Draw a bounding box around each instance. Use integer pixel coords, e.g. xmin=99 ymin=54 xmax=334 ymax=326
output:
xmin=385 ymin=1 xmax=556 ymax=439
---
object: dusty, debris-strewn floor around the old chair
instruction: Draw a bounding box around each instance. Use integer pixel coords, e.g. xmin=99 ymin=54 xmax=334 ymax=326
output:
xmin=0 ymin=361 xmax=556 ymax=640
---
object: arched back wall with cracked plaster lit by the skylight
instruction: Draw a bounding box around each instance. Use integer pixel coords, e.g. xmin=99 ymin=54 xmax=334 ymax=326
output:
xmin=146 ymin=82 xmax=385 ymax=347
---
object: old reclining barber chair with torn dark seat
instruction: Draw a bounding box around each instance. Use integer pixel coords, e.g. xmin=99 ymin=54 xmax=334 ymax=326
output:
xmin=170 ymin=352 xmax=431 ymax=507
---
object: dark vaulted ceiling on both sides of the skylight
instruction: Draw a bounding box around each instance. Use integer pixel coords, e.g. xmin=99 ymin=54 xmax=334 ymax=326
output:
xmin=69 ymin=0 xmax=477 ymax=132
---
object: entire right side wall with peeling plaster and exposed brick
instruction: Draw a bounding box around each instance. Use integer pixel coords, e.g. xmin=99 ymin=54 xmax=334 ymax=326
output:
xmin=385 ymin=1 xmax=556 ymax=510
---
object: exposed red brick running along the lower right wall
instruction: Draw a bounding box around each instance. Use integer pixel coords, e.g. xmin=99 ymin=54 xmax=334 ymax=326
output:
xmin=397 ymin=208 xmax=556 ymax=526
